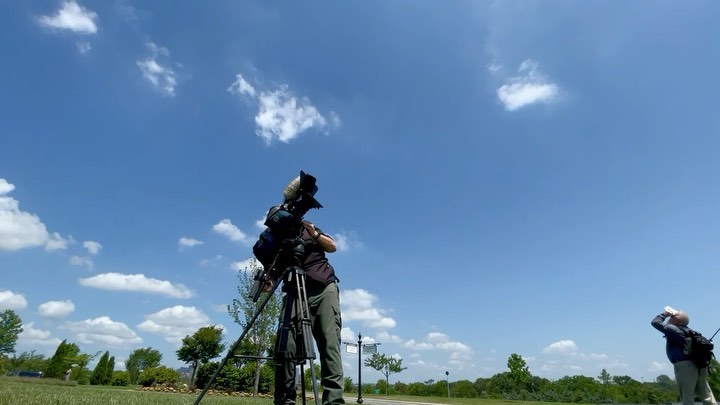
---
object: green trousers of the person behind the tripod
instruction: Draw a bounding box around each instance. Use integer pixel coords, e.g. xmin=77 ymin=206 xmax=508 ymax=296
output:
xmin=273 ymin=283 xmax=345 ymax=405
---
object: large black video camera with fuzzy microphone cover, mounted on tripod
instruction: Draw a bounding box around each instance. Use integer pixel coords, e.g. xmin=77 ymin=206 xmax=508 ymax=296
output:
xmin=250 ymin=170 xmax=322 ymax=302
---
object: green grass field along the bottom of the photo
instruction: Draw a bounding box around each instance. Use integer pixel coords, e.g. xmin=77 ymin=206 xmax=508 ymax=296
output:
xmin=0 ymin=378 xmax=567 ymax=405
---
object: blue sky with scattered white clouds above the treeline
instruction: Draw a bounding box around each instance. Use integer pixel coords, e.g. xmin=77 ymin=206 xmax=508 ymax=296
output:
xmin=0 ymin=0 xmax=720 ymax=381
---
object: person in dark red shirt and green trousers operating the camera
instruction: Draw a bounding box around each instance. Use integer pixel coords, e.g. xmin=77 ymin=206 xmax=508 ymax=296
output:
xmin=266 ymin=177 xmax=345 ymax=405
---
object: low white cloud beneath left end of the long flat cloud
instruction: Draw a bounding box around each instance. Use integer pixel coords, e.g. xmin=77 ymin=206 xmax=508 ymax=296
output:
xmin=63 ymin=316 xmax=142 ymax=347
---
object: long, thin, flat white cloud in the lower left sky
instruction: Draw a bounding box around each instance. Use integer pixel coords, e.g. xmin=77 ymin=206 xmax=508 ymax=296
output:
xmin=78 ymin=273 xmax=194 ymax=298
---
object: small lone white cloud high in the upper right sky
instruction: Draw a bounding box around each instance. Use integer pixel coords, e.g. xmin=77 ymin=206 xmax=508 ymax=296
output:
xmin=497 ymin=59 xmax=559 ymax=111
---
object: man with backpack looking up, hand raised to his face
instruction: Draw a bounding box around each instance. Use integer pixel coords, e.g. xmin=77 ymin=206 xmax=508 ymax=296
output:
xmin=650 ymin=307 xmax=717 ymax=405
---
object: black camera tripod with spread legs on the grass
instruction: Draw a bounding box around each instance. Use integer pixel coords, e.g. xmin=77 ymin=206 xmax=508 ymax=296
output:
xmin=194 ymin=266 xmax=320 ymax=405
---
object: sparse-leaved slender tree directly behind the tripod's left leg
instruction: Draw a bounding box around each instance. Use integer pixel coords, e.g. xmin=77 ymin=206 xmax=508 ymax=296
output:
xmin=228 ymin=259 xmax=282 ymax=396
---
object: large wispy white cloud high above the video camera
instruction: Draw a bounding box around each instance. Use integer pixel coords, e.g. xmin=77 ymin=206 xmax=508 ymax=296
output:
xmin=227 ymin=74 xmax=340 ymax=145
